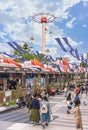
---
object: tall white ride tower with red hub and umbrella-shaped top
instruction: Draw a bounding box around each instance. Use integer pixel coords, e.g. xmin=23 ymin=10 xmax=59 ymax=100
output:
xmin=32 ymin=13 xmax=56 ymax=54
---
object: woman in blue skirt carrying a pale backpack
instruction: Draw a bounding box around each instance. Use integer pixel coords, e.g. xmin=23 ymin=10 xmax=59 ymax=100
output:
xmin=40 ymin=96 xmax=51 ymax=128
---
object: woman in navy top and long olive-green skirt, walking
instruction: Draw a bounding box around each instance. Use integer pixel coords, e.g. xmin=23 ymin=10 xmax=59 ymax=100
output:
xmin=30 ymin=94 xmax=40 ymax=125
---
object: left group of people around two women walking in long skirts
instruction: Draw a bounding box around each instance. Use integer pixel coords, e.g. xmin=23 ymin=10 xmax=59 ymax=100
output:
xmin=16 ymin=88 xmax=63 ymax=128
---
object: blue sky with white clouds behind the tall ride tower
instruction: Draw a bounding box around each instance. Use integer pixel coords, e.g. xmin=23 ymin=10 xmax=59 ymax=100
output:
xmin=0 ymin=0 xmax=88 ymax=63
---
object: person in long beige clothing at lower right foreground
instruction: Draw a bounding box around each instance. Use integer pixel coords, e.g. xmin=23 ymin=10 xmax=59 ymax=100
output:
xmin=74 ymin=99 xmax=83 ymax=130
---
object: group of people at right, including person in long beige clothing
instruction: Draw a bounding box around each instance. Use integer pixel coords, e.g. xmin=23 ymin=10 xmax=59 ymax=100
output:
xmin=64 ymin=83 xmax=88 ymax=130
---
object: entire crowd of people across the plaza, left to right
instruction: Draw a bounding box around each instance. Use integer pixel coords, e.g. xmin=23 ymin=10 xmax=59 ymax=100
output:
xmin=17 ymin=82 xmax=88 ymax=130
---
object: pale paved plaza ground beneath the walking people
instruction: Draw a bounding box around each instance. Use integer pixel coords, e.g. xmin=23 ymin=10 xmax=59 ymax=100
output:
xmin=0 ymin=96 xmax=88 ymax=130
